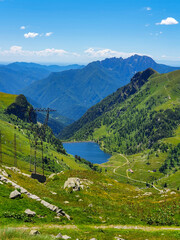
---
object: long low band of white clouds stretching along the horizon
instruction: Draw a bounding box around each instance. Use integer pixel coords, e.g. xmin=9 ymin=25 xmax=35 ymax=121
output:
xmin=0 ymin=45 xmax=148 ymax=64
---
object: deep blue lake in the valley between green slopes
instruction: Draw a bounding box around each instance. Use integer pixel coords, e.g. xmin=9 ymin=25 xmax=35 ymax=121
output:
xmin=63 ymin=142 xmax=111 ymax=164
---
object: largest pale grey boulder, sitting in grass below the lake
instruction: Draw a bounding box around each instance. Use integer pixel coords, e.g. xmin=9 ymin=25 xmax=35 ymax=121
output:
xmin=64 ymin=177 xmax=92 ymax=191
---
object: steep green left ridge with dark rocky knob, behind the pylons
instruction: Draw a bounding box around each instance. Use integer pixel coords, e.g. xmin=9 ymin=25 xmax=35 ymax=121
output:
xmin=0 ymin=93 xmax=93 ymax=174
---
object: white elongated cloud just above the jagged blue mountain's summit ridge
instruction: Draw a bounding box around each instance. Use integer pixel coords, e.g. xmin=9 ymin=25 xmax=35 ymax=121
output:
xmin=84 ymin=48 xmax=141 ymax=59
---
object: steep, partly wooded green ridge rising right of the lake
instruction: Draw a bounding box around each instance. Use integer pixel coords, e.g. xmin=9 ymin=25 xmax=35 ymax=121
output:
xmin=60 ymin=69 xmax=180 ymax=153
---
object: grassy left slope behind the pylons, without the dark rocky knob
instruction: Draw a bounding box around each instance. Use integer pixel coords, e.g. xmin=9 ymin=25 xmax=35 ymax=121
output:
xmin=0 ymin=93 xmax=94 ymax=174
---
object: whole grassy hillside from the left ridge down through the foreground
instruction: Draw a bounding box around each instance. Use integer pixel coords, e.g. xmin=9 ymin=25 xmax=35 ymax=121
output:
xmin=0 ymin=94 xmax=180 ymax=240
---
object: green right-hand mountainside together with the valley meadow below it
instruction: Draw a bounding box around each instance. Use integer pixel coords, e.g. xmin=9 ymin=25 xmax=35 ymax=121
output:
xmin=60 ymin=71 xmax=180 ymax=189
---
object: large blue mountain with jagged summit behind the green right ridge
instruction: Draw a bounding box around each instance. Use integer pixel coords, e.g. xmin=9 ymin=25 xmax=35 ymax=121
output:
xmin=23 ymin=55 xmax=180 ymax=120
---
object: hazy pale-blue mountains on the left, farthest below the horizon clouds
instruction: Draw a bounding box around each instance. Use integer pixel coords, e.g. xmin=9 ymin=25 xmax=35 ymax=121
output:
xmin=0 ymin=62 xmax=83 ymax=94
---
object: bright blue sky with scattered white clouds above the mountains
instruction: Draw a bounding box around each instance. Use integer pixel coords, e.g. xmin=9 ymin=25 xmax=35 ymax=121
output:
xmin=0 ymin=0 xmax=180 ymax=66
